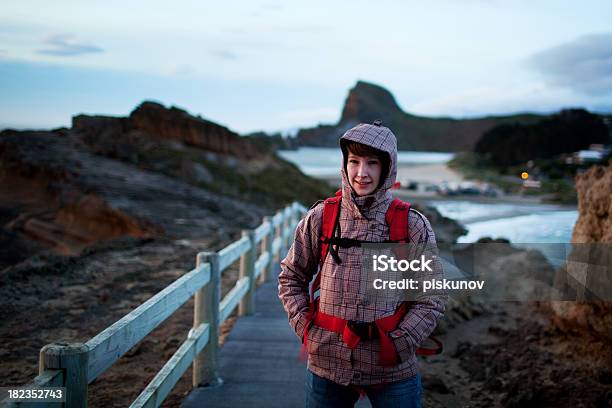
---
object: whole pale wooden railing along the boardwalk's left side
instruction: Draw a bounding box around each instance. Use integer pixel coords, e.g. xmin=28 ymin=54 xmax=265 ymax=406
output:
xmin=4 ymin=203 xmax=306 ymax=408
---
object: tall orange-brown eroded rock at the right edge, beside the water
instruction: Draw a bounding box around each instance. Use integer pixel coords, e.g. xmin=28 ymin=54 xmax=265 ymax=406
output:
xmin=551 ymin=163 xmax=612 ymax=339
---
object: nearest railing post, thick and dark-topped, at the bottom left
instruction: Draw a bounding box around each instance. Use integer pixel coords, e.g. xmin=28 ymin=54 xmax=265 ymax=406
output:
xmin=38 ymin=343 xmax=89 ymax=408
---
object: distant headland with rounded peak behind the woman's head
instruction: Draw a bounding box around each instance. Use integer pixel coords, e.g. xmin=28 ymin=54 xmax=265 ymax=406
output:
xmin=297 ymin=81 xmax=541 ymax=151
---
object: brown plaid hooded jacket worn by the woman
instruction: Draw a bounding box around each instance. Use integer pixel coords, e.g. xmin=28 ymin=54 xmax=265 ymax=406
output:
xmin=278 ymin=124 xmax=445 ymax=385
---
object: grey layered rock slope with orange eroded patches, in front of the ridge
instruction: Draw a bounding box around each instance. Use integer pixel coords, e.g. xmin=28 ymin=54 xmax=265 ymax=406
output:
xmin=0 ymin=126 xmax=264 ymax=270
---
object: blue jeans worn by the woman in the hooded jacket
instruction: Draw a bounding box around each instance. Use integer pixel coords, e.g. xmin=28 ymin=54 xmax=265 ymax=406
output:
xmin=306 ymin=370 xmax=421 ymax=408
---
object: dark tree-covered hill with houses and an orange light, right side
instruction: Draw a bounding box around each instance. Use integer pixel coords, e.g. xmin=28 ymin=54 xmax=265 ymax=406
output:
xmin=449 ymin=109 xmax=610 ymax=204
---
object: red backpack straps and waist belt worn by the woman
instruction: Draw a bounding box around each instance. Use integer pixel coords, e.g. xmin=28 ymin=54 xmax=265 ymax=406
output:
xmin=303 ymin=190 xmax=442 ymax=366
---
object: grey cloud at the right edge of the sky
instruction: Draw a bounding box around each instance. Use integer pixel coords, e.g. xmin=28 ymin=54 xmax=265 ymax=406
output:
xmin=527 ymin=33 xmax=612 ymax=96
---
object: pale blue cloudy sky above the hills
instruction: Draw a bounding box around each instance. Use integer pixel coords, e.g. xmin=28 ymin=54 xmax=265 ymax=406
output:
xmin=0 ymin=0 xmax=612 ymax=133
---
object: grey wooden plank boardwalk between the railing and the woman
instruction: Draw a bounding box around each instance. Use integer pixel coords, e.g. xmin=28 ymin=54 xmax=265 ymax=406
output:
xmin=181 ymin=268 xmax=306 ymax=408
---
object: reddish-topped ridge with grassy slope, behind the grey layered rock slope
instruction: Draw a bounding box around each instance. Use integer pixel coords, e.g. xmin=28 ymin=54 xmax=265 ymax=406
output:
xmin=72 ymin=102 xmax=329 ymax=208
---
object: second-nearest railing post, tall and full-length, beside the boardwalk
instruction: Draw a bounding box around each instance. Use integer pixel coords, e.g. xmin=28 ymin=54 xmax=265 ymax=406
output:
xmin=193 ymin=252 xmax=223 ymax=387
